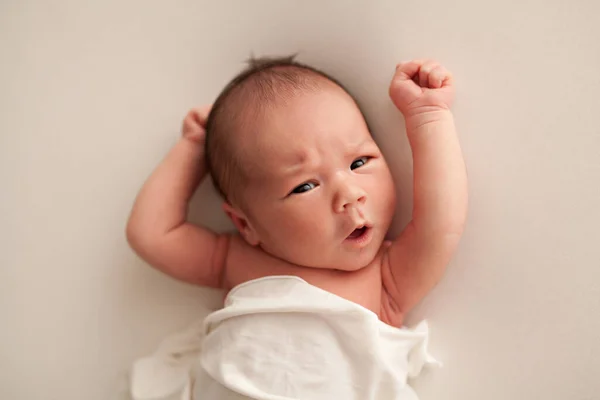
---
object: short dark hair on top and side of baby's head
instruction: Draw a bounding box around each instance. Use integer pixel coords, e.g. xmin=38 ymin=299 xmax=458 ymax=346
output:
xmin=206 ymin=55 xmax=350 ymax=205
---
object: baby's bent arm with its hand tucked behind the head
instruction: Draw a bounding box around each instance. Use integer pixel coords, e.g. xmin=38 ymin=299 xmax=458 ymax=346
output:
xmin=127 ymin=108 xmax=228 ymax=288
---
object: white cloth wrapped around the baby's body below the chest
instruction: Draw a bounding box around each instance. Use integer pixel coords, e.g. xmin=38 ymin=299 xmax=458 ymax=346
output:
xmin=132 ymin=276 xmax=437 ymax=400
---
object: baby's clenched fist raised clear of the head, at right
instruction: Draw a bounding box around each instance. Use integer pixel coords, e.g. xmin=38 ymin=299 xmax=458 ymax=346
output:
xmin=389 ymin=60 xmax=454 ymax=118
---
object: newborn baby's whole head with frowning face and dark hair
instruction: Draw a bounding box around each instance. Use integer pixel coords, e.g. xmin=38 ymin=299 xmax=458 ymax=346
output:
xmin=206 ymin=57 xmax=396 ymax=271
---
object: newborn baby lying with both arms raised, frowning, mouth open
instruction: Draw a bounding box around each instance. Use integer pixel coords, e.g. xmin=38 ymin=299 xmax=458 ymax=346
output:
xmin=127 ymin=58 xmax=467 ymax=398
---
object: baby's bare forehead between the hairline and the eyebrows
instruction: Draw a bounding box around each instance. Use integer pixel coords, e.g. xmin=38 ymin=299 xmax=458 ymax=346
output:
xmin=238 ymin=88 xmax=371 ymax=177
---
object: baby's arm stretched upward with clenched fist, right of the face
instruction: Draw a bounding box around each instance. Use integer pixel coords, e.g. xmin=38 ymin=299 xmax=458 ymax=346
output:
xmin=382 ymin=61 xmax=467 ymax=319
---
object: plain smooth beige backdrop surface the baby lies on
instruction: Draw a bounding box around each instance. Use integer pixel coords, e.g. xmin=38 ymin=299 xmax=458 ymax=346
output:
xmin=0 ymin=0 xmax=600 ymax=400
